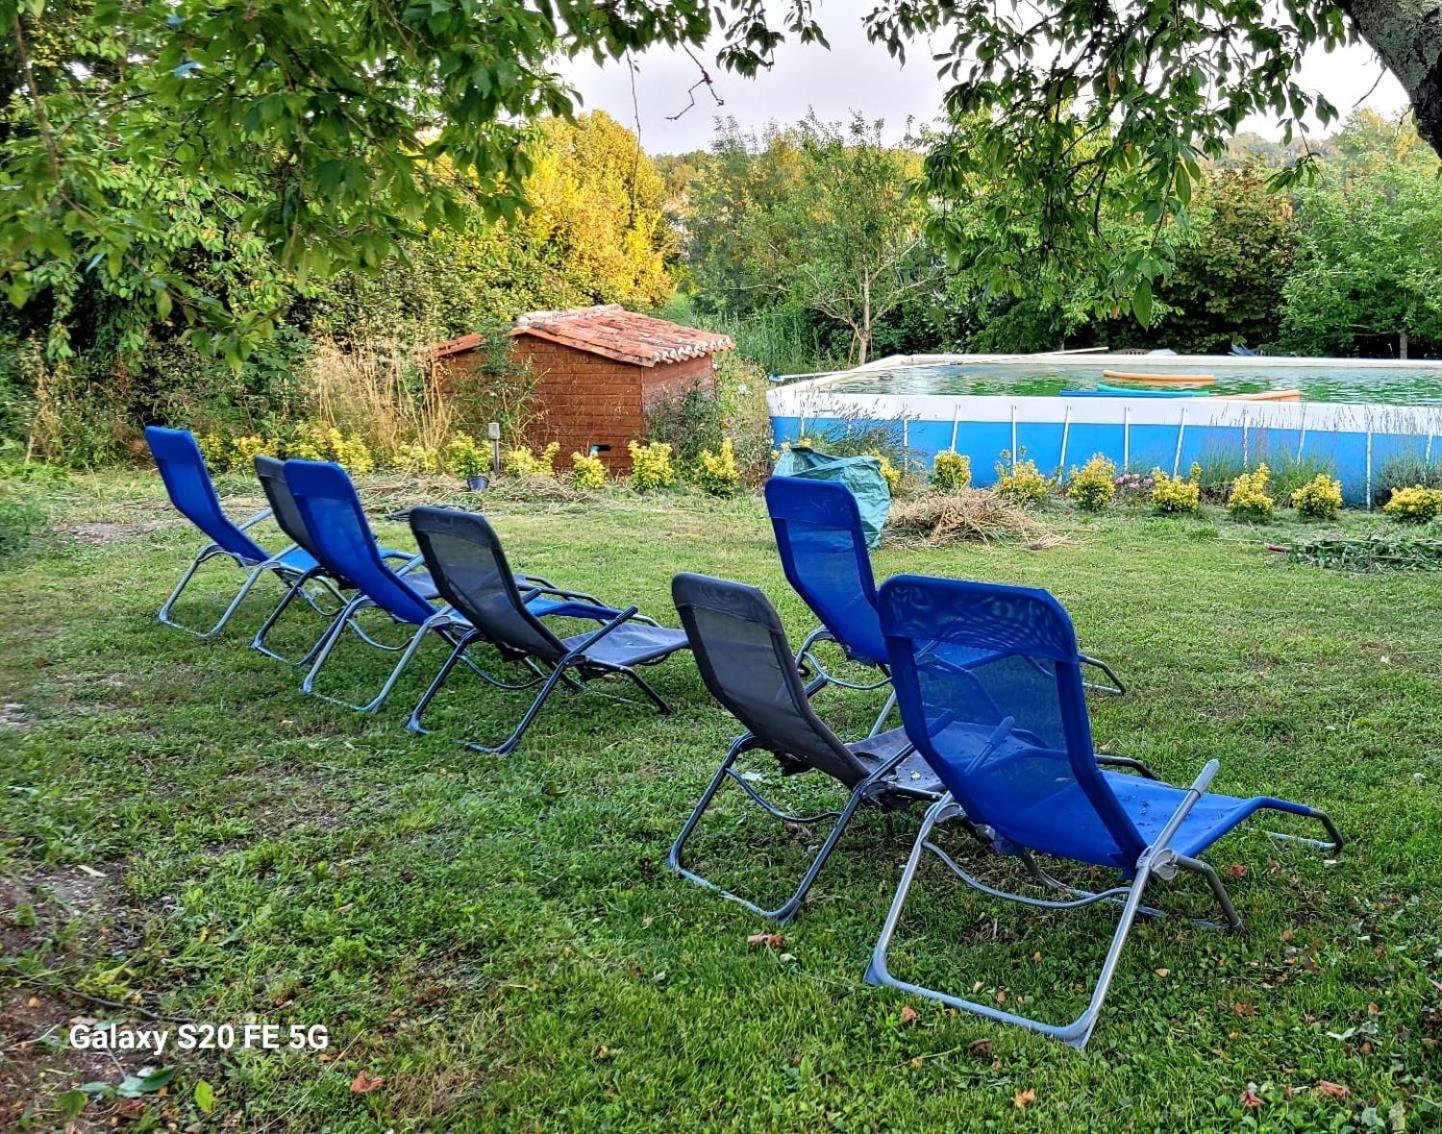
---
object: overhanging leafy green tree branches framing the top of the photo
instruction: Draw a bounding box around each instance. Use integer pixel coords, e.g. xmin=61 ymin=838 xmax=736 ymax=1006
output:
xmin=0 ymin=0 xmax=1442 ymax=353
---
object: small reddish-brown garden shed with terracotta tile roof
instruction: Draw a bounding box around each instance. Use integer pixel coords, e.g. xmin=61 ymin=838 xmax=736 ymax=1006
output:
xmin=428 ymin=304 xmax=733 ymax=473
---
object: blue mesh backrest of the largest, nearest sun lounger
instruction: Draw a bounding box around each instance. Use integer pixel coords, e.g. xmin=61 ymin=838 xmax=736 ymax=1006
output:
xmin=880 ymin=576 xmax=1145 ymax=870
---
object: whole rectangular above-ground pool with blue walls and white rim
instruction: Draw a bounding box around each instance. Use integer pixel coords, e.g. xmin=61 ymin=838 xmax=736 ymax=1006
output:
xmin=767 ymin=353 xmax=1442 ymax=505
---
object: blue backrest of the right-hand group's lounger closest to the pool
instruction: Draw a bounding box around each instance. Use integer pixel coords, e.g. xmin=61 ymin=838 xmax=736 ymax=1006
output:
xmin=766 ymin=476 xmax=887 ymax=665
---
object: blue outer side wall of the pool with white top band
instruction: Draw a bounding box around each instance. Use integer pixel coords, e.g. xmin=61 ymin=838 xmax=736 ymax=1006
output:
xmin=770 ymin=387 xmax=1442 ymax=506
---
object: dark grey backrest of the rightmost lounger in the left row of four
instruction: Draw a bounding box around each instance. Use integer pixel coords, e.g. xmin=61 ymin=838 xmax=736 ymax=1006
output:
xmin=411 ymin=508 xmax=567 ymax=662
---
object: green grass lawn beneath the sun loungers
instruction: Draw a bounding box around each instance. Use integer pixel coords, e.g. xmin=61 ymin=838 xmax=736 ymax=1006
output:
xmin=0 ymin=478 xmax=1442 ymax=1131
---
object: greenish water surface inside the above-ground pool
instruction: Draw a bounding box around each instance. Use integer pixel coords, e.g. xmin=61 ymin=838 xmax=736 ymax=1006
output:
xmin=826 ymin=355 xmax=1442 ymax=405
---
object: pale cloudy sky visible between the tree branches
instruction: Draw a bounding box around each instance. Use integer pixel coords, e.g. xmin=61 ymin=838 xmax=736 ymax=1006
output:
xmin=561 ymin=0 xmax=1407 ymax=154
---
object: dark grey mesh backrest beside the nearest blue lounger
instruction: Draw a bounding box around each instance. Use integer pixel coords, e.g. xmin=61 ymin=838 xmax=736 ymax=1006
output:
xmin=671 ymin=574 xmax=867 ymax=786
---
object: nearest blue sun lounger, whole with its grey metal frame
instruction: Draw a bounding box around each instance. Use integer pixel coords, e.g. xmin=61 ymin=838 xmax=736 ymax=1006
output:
xmin=867 ymin=576 xmax=1343 ymax=1047
